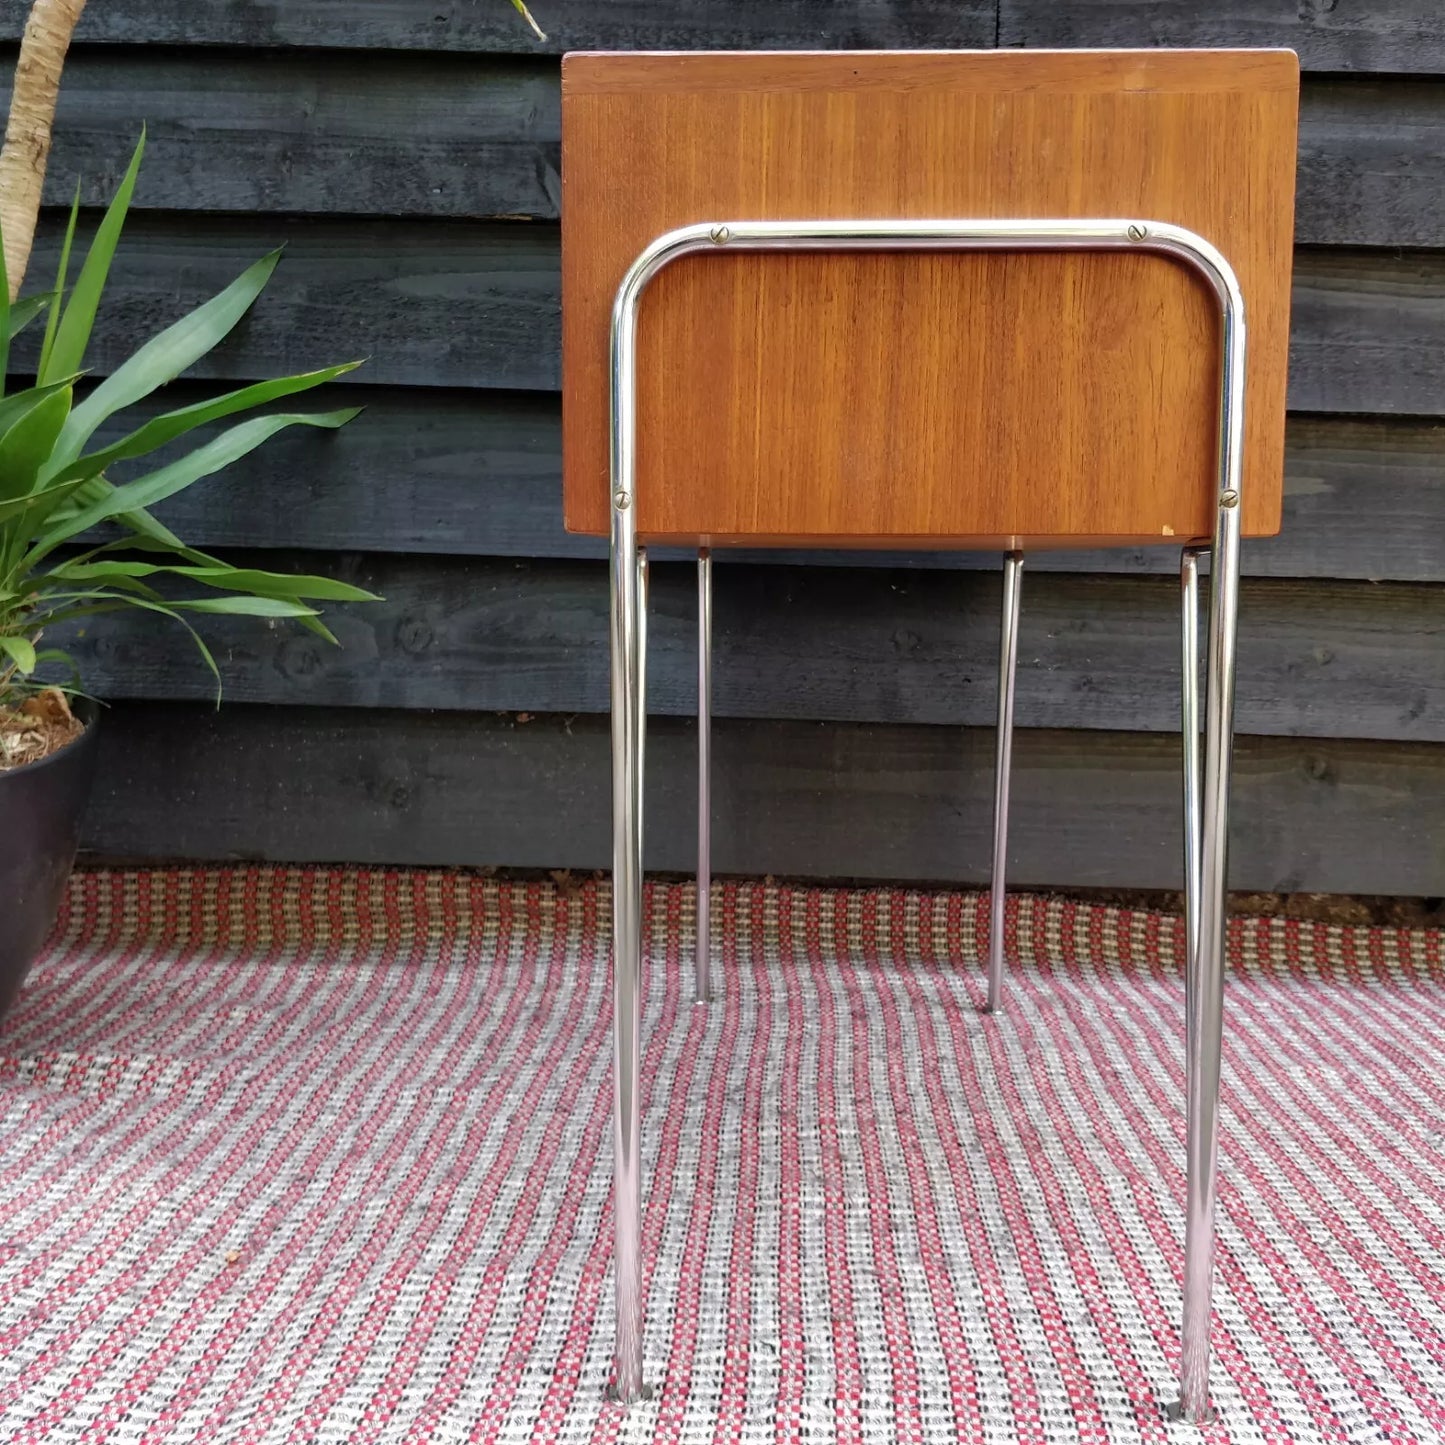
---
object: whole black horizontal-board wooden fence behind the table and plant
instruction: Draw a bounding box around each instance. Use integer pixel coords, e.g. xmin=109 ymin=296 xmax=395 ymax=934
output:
xmin=0 ymin=0 xmax=1445 ymax=894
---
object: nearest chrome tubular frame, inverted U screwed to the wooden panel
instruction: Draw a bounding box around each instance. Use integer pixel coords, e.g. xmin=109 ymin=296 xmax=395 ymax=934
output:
xmin=610 ymin=218 xmax=1244 ymax=1422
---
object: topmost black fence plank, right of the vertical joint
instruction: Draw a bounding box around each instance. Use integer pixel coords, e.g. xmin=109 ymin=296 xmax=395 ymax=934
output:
xmin=998 ymin=0 xmax=1445 ymax=71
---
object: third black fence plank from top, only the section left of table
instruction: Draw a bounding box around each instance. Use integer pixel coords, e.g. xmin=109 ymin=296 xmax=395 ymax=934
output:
xmin=12 ymin=212 xmax=561 ymax=390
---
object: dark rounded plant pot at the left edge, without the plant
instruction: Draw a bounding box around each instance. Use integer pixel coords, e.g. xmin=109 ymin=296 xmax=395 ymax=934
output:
xmin=0 ymin=699 xmax=100 ymax=1014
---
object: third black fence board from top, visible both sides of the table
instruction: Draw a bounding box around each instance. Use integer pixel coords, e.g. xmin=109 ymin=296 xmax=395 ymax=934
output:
xmin=14 ymin=212 xmax=1445 ymax=416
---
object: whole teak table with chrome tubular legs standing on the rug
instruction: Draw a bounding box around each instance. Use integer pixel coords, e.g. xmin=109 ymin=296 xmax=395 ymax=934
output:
xmin=562 ymin=51 xmax=1299 ymax=1422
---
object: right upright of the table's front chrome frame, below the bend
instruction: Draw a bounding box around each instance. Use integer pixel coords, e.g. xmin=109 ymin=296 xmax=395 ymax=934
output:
xmin=1175 ymin=276 xmax=1244 ymax=1423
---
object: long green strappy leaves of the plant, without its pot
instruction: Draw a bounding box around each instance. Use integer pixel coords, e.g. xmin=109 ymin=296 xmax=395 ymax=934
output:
xmin=0 ymin=136 xmax=374 ymax=734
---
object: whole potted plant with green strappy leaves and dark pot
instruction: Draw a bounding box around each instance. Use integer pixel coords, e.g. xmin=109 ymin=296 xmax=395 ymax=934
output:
xmin=0 ymin=137 xmax=374 ymax=1010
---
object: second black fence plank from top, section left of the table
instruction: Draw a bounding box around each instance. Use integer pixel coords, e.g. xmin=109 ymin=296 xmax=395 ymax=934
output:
xmin=0 ymin=51 xmax=561 ymax=220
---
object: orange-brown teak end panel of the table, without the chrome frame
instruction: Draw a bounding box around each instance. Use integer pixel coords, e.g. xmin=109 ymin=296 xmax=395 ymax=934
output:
xmin=562 ymin=51 xmax=1299 ymax=548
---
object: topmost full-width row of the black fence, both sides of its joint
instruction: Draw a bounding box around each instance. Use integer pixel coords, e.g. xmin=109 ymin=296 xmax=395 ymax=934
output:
xmin=11 ymin=0 xmax=1445 ymax=72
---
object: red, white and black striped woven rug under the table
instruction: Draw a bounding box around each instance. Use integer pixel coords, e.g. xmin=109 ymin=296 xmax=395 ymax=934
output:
xmin=0 ymin=868 xmax=1445 ymax=1442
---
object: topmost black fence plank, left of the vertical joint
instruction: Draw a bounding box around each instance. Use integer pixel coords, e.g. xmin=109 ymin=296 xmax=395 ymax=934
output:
xmin=0 ymin=0 xmax=996 ymax=55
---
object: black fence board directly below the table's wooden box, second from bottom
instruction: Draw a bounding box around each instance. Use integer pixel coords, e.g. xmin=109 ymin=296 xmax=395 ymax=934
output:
xmin=48 ymin=553 xmax=1445 ymax=741
